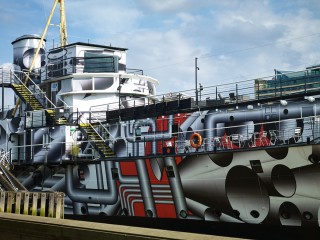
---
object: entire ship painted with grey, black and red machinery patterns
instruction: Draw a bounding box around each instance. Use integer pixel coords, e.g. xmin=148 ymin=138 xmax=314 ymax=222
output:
xmin=0 ymin=1 xmax=320 ymax=232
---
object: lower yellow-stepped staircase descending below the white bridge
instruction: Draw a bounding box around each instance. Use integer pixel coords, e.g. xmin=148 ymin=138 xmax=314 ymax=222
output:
xmin=79 ymin=123 xmax=116 ymax=158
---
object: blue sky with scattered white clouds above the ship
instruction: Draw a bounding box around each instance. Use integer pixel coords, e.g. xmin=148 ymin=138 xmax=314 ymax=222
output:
xmin=0 ymin=0 xmax=320 ymax=92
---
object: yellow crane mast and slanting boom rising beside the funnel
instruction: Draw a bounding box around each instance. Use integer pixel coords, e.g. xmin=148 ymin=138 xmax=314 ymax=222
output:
xmin=12 ymin=0 xmax=68 ymax=116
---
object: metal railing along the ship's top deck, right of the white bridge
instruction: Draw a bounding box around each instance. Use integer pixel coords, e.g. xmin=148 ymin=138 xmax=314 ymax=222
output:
xmin=90 ymin=67 xmax=320 ymax=112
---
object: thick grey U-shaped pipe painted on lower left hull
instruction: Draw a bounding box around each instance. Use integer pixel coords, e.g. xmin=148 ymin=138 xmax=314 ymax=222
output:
xmin=66 ymin=161 xmax=118 ymax=204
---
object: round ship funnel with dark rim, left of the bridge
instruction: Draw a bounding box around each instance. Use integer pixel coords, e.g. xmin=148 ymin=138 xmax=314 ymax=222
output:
xmin=11 ymin=34 xmax=45 ymax=82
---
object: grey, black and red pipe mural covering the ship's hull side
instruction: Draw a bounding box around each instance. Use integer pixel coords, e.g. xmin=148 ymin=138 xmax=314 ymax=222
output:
xmin=1 ymin=100 xmax=320 ymax=227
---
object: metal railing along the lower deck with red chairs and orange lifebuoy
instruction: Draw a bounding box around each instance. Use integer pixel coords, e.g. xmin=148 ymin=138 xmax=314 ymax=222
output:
xmin=11 ymin=116 xmax=320 ymax=164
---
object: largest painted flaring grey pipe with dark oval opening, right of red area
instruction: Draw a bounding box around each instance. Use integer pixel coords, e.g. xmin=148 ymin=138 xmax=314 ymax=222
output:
xmin=179 ymin=155 xmax=269 ymax=223
